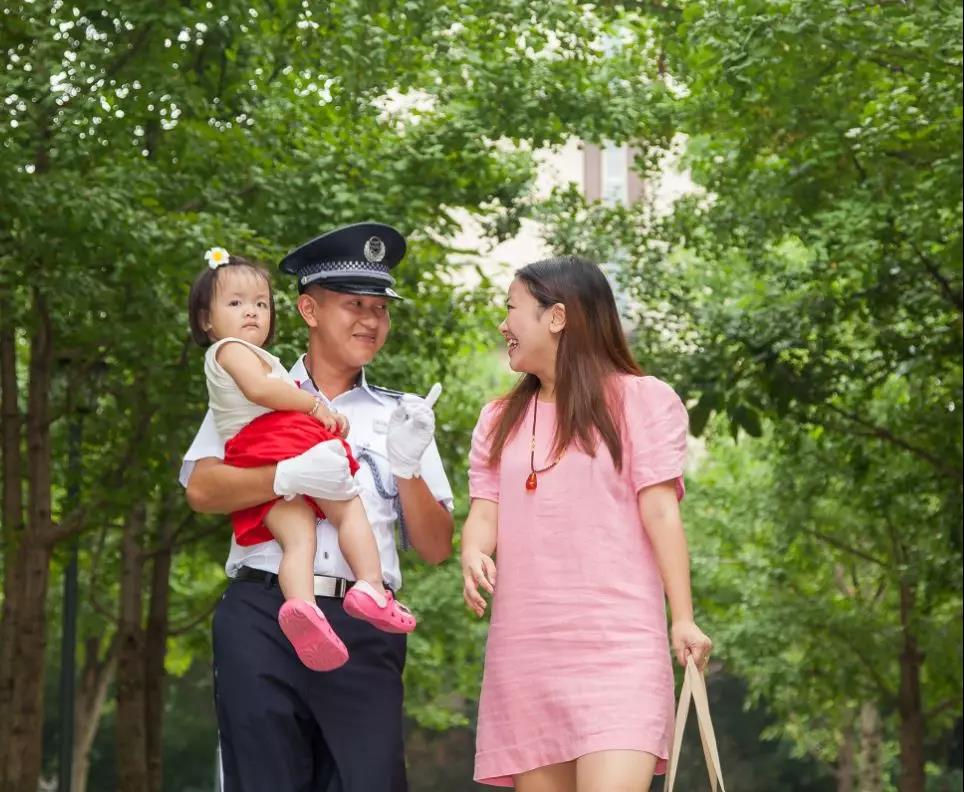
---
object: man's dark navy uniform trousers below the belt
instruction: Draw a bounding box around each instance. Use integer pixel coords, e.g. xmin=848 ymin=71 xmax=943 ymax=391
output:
xmin=213 ymin=576 xmax=408 ymax=792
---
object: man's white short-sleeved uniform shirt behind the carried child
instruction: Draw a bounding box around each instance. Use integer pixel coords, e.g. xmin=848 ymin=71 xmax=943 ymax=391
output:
xmin=180 ymin=358 xmax=453 ymax=589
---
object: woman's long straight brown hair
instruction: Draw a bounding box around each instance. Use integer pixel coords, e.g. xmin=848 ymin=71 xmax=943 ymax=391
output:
xmin=489 ymin=256 xmax=643 ymax=470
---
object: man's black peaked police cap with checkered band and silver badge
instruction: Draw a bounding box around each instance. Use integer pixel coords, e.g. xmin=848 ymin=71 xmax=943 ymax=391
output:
xmin=280 ymin=223 xmax=405 ymax=300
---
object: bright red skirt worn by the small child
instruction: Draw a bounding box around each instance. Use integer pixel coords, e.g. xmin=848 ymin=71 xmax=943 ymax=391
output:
xmin=224 ymin=412 xmax=358 ymax=546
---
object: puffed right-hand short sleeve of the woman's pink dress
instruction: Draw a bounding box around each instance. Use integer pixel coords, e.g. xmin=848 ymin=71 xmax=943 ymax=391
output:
xmin=624 ymin=377 xmax=689 ymax=500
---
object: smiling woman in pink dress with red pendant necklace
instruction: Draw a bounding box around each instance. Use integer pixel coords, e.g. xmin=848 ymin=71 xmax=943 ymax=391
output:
xmin=462 ymin=257 xmax=711 ymax=792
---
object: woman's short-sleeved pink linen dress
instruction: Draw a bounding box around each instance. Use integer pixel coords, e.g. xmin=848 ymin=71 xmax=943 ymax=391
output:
xmin=469 ymin=376 xmax=687 ymax=786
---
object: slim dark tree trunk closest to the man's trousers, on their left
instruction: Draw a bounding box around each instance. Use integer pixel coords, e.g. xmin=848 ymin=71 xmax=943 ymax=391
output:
xmin=144 ymin=520 xmax=171 ymax=792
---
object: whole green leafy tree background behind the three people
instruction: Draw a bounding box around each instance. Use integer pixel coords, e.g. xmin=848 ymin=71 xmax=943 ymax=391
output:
xmin=0 ymin=0 xmax=962 ymax=791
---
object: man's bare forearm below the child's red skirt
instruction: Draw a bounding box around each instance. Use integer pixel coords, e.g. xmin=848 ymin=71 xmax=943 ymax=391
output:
xmin=187 ymin=457 xmax=278 ymax=514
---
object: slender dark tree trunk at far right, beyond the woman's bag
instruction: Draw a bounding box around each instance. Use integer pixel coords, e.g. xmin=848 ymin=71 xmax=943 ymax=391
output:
xmin=898 ymin=582 xmax=926 ymax=792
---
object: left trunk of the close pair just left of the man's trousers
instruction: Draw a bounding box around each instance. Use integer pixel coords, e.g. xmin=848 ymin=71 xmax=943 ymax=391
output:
xmin=117 ymin=503 xmax=150 ymax=792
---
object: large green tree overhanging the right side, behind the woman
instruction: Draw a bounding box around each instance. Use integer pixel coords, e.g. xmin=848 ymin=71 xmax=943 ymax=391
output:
xmin=541 ymin=0 xmax=962 ymax=792
